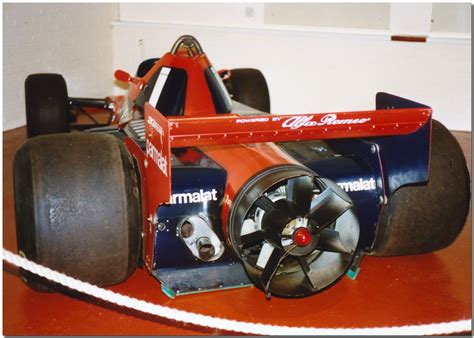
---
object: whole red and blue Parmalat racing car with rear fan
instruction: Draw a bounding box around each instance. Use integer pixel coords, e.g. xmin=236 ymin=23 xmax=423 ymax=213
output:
xmin=14 ymin=36 xmax=470 ymax=297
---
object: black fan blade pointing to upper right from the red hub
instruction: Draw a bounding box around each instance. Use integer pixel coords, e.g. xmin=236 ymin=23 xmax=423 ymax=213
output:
xmin=309 ymin=188 xmax=352 ymax=227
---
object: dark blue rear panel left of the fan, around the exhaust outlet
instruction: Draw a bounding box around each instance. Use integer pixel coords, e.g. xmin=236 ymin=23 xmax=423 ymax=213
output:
xmin=152 ymin=148 xmax=252 ymax=297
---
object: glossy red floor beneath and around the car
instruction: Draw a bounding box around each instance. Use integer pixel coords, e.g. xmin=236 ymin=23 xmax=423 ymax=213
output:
xmin=3 ymin=128 xmax=472 ymax=335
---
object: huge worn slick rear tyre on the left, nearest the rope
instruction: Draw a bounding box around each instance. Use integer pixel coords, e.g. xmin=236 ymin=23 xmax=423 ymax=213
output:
xmin=14 ymin=133 xmax=141 ymax=291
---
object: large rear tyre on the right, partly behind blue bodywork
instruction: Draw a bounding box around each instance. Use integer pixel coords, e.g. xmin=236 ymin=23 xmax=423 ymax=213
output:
xmin=371 ymin=120 xmax=470 ymax=256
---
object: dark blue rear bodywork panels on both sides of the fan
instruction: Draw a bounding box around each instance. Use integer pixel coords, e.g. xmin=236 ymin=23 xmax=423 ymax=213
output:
xmin=153 ymin=93 xmax=431 ymax=295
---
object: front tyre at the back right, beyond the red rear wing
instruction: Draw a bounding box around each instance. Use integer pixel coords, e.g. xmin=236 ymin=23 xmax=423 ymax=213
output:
xmin=226 ymin=68 xmax=270 ymax=113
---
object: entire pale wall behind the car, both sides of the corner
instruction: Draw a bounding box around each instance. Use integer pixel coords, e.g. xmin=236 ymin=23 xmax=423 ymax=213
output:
xmin=3 ymin=3 xmax=471 ymax=130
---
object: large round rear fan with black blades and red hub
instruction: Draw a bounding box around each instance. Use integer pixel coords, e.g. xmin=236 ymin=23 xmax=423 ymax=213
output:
xmin=233 ymin=175 xmax=359 ymax=297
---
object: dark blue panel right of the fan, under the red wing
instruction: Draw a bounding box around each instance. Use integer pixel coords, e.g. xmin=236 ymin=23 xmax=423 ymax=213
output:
xmin=279 ymin=117 xmax=431 ymax=250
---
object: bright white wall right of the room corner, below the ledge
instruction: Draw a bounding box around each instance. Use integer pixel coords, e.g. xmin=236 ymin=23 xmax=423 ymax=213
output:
xmin=113 ymin=4 xmax=471 ymax=130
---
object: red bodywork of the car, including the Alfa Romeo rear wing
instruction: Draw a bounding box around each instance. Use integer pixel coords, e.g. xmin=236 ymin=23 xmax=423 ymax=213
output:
xmin=115 ymin=48 xmax=431 ymax=270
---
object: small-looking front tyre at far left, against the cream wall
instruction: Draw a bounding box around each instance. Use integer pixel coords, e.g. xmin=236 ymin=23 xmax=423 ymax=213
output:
xmin=25 ymin=74 xmax=69 ymax=137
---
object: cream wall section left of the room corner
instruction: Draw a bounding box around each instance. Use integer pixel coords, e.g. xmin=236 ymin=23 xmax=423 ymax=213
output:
xmin=3 ymin=3 xmax=118 ymax=130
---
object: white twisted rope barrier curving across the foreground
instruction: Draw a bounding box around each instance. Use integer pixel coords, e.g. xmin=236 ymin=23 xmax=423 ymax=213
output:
xmin=3 ymin=249 xmax=471 ymax=336
